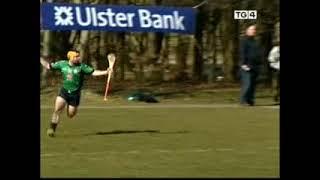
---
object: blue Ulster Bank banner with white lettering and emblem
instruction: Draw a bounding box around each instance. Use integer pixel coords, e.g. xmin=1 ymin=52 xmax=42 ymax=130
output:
xmin=41 ymin=3 xmax=195 ymax=33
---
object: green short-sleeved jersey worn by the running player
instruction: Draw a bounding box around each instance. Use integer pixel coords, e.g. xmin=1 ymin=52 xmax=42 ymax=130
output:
xmin=50 ymin=60 xmax=94 ymax=93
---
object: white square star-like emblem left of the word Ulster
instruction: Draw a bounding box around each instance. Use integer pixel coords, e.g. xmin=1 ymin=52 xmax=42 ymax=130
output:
xmin=54 ymin=6 xmax=73 ymax=26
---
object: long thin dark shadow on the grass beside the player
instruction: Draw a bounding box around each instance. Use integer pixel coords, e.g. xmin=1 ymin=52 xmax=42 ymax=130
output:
xmin=86 ymin=130 xmax=189 ymax=136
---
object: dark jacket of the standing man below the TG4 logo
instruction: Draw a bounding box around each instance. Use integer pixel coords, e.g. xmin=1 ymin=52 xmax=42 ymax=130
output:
xmin=239 ymin=36 xmax=262 ymax=70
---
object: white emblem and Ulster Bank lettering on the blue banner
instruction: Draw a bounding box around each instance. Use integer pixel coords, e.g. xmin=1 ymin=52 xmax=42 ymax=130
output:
xmin=54 ymin=6 xmax=185 ymax=30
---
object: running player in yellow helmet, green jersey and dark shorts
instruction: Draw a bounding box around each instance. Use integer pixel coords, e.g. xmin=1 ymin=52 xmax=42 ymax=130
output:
xmin=40 ymin=51 xmax=111 ymax=137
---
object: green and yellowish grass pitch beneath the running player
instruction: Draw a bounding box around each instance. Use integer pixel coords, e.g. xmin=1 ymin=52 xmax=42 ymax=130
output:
xmin=41 ymin=87 xmax=279 ymax=177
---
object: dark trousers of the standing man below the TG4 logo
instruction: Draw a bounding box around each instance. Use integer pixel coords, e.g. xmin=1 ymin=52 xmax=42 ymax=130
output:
xmin=240 ymin=69 xmax=258 ymax=105
